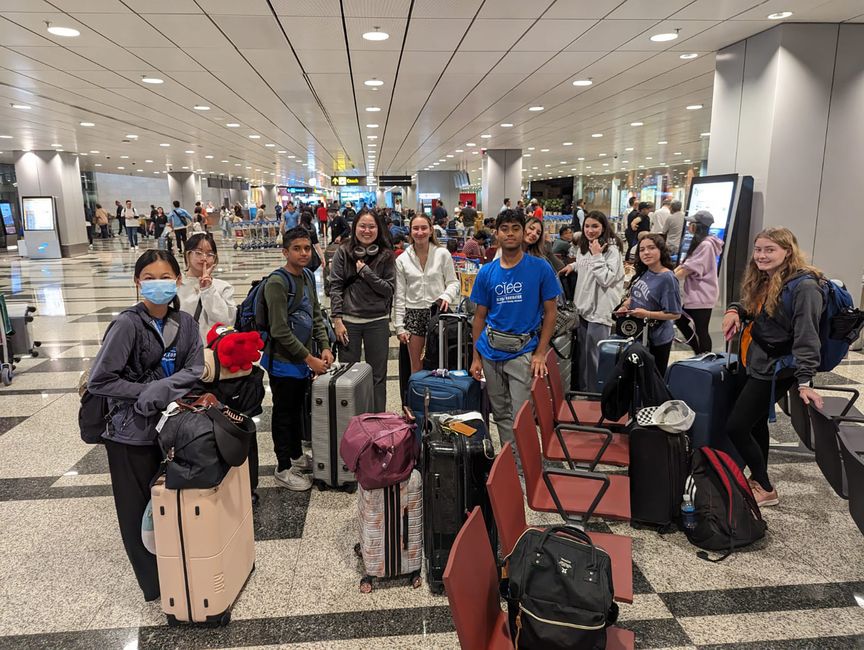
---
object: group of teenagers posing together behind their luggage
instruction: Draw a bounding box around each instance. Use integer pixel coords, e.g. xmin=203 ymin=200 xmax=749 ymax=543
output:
xmin=88 ymin=201 xmax=823 ymax=600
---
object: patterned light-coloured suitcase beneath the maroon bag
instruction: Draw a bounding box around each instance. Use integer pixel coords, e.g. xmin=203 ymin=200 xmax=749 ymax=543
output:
xmin=354 ymin=469 xmax=423 ymax=593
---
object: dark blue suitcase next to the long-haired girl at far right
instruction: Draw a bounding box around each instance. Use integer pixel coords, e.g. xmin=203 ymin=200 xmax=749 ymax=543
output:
xmin=666 ymin=352 xmax=744 ymax=462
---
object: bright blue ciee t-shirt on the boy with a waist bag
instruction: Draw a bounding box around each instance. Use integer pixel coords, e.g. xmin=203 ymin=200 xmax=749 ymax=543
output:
xmin=471 ymin=255 xmax=561 ymax=361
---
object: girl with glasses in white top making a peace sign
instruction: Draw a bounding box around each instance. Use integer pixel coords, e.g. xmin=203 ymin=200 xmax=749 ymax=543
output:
xmin=177 ymin=233 xmax=237 ymax=339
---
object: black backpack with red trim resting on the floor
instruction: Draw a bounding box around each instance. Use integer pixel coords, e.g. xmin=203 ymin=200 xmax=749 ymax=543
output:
xmin=684 ymin=447 xmax=768 ymax=562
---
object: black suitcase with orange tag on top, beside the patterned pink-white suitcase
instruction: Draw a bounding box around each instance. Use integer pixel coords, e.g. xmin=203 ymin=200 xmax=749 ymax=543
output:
xmin=422 ymin=413 xmax=498 ymax=594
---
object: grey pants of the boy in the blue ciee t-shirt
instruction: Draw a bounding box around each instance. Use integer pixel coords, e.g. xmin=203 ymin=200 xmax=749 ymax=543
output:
xmin=482 ymin=352 xmax=532 ymax=448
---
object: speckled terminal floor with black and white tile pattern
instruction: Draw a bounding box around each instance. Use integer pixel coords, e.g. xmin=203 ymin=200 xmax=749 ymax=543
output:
xmin=0 ymin=235 xmax=864 ymax=650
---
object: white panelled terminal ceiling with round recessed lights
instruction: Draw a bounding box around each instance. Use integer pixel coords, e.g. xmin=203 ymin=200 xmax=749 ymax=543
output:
xmin=0 ymin=0 xmax=864 ymax=184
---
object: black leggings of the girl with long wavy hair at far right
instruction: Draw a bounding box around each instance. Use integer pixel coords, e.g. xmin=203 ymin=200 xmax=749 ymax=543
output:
xmin=726 ymin=377 xmax=795 ymax=492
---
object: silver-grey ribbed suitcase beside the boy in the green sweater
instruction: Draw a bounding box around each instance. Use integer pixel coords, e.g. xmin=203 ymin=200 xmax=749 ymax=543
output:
xmin=311 ymin=363 xmax=374 ymax=489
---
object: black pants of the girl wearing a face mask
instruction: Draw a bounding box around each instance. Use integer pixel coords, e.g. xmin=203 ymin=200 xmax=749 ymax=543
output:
xmin=105 ymin=441 xmax=162 ymax=601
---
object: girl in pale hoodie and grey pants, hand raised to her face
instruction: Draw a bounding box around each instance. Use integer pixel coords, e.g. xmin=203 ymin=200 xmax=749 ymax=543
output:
xmin=561 ymin=210 xmax=624 ymax=391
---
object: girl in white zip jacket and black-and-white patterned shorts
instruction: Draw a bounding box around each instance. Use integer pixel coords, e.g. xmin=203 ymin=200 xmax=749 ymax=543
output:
xmin=396 ymin=214 xmax=459 ymax=373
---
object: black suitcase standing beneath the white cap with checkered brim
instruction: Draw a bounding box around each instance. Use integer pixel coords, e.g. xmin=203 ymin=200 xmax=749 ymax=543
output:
xmin=628 ymin=424 xmax=690 ymax=531
